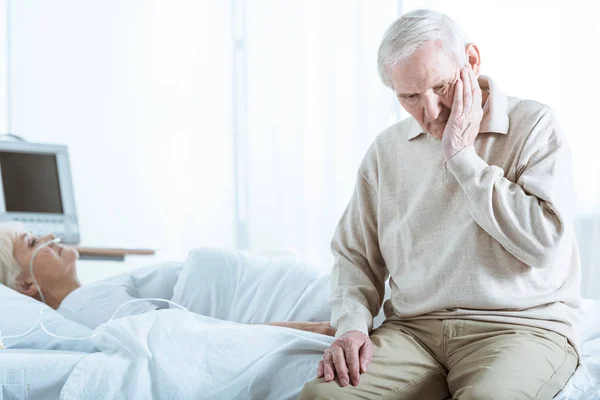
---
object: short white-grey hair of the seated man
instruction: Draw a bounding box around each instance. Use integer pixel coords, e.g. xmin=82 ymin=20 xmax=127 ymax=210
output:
xmin=377 ymin=10 xmax=469 ymax=89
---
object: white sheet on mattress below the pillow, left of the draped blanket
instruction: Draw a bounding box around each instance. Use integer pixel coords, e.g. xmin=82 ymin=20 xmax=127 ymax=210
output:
xmin=0 ymin=349 xmax=89 ymax=400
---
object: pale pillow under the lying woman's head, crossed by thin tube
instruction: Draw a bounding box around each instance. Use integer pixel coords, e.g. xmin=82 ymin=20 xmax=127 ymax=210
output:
xmin=0 ymin=285 xmax=96 ymax=354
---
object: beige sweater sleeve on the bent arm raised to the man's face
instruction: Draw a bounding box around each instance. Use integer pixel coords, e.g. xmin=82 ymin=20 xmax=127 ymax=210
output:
xmin=447 ymin=112 xmax=575 ymax=268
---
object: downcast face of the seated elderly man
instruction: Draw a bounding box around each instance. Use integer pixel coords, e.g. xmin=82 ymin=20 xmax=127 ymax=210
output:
xmin=390 ymin=41 xmax=460 ymax=139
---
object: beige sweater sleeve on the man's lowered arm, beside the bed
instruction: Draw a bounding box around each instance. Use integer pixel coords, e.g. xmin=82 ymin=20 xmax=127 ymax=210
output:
xmin=330 ymin=173 xmax=388 ymax=337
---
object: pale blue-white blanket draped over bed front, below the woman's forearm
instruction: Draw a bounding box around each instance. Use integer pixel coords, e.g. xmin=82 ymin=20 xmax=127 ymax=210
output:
xmin=61 ymin=310 xmax=334 ymax=400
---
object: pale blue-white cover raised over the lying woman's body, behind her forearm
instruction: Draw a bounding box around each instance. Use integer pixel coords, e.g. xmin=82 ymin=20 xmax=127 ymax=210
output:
xmin=173 ymin=248 xmax=330 ymax=323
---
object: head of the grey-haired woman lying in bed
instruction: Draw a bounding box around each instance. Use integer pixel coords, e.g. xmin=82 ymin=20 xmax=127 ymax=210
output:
xmin=0 ymin=222 xmax=81 ymax=308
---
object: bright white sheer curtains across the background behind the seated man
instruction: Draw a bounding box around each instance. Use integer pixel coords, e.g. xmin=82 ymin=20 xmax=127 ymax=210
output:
xmin=8 ymin=0 xmax=600 ymax=298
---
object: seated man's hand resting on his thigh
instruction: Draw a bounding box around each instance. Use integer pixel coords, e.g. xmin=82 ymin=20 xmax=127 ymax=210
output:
xmin=317 ymin=331 xmax=373 ymax=386
